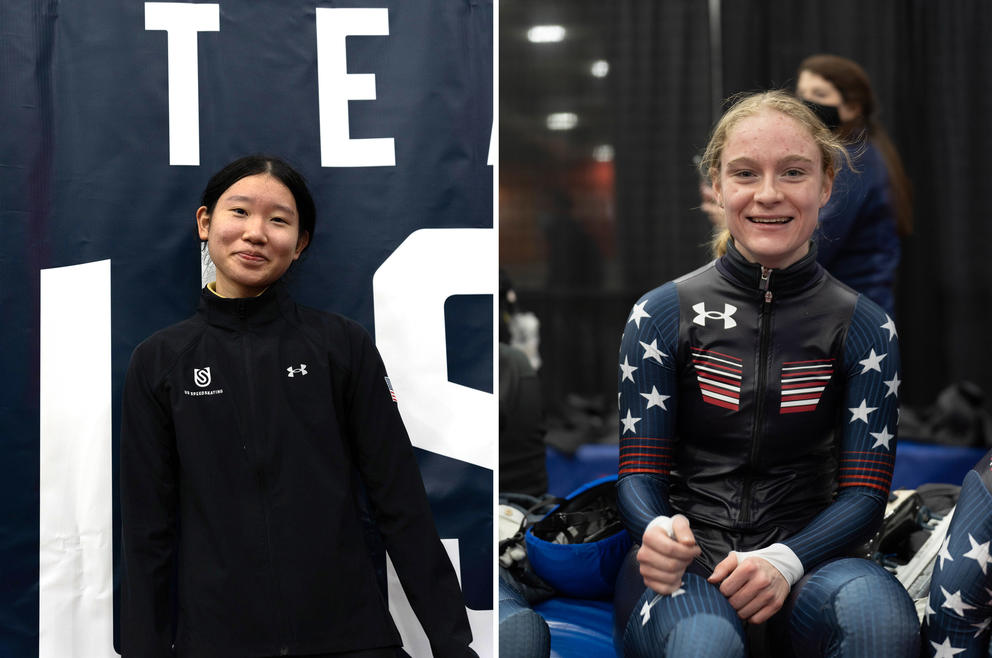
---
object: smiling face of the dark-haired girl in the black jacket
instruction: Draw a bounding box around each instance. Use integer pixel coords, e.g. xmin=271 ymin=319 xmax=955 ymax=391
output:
xmin=196 ymin=174 xmax=310 ymax=297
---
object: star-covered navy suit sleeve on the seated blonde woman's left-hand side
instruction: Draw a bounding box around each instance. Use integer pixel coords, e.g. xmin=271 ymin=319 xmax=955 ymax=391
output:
xmin=617 ymin=283 xmax=679 ymax=542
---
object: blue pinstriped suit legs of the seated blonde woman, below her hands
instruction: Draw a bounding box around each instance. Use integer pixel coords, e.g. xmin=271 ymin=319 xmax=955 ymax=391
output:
xmin=616 ymin=552 xmax=920 ymax=658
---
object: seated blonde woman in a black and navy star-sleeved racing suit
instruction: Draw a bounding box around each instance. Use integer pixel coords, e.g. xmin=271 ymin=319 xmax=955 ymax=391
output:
xmin=615 ymin=91 xmax=919 ymax=658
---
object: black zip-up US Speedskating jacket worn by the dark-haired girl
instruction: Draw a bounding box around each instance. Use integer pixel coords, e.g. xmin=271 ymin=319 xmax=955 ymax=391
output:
xmin=120 ymin=285 xmax=474 ymax=658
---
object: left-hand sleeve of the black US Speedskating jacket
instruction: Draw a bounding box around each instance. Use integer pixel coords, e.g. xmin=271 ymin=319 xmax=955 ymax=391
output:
xmin=120 ymin=346 xmax=179 ymax=658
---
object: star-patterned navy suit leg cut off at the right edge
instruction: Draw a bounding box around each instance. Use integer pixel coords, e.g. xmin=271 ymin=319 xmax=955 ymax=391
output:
xmin=923 ymin=450 xmax=992 ymax=658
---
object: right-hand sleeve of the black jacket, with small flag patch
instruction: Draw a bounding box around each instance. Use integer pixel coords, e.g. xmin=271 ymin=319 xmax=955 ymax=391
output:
xmin=345 ymin=327 xmax=476 ymax=658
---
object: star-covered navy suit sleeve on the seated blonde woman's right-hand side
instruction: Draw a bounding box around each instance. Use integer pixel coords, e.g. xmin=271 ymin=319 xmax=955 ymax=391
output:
xmin=782 ymin=295 xmax=900 ymax=571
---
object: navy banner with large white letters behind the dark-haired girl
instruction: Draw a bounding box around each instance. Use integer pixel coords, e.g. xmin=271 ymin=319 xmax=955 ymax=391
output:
xmin=0 ymin=0 xmax=497 ymax=658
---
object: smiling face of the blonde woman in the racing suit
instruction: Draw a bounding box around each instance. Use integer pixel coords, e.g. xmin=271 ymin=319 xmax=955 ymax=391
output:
xmin=713 ymin=108 xmax=833 ymax=269
